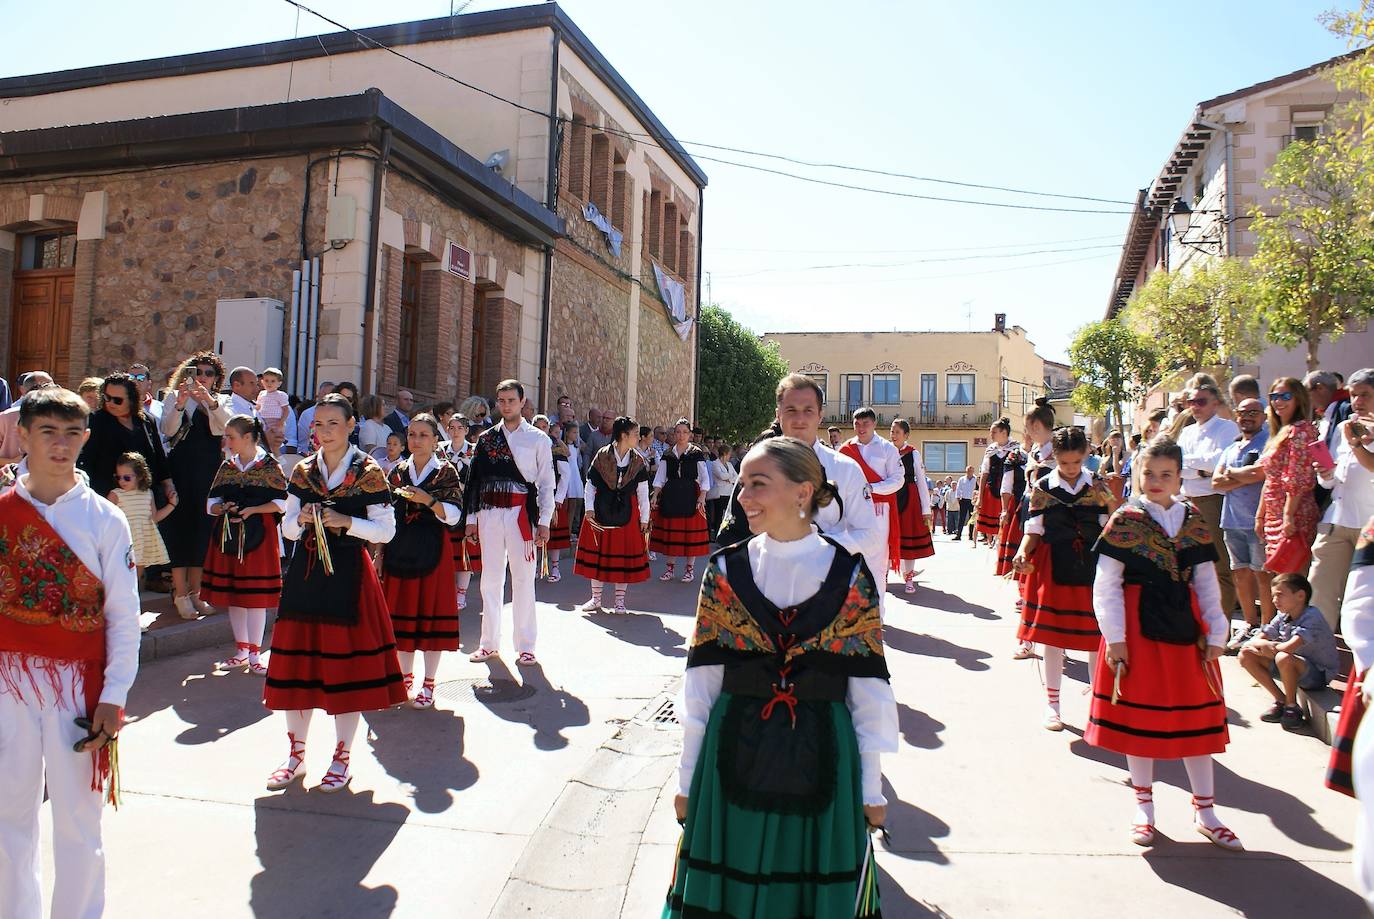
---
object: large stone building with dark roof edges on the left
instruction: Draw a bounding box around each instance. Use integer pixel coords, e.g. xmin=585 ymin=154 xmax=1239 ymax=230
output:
xmin=0 ymin=3 xmax=706 ymax=419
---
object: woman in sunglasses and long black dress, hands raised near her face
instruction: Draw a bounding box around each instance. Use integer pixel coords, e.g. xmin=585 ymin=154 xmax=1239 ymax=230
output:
xmin=161 ymin=352 xmax=234 ymax=618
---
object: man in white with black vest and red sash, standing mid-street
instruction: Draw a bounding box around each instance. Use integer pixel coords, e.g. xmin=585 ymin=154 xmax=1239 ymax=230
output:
xmin=463 ymin=379 xmax=554 ymax=666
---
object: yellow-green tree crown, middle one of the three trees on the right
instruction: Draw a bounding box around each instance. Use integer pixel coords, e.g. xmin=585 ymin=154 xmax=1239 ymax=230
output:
xmin=1124 ymin=258 xmax=1263 ymax=375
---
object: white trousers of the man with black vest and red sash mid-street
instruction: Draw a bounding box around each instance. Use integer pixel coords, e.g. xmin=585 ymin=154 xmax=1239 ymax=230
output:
xmin=477 ymin=507 xmax=539 ymax=654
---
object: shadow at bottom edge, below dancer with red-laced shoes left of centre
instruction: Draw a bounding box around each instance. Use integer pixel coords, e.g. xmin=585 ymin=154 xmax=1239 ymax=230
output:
xmin=249 ymin=788 xmax=409 ymax=919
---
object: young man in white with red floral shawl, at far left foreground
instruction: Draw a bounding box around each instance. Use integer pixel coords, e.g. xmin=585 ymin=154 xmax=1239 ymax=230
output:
xmin=0 ymin=387 xmax=139 ymax=919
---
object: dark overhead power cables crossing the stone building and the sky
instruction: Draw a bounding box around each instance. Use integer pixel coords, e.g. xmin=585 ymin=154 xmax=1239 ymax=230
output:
xmin=283 ymin=0 xmax=1135 ymax=214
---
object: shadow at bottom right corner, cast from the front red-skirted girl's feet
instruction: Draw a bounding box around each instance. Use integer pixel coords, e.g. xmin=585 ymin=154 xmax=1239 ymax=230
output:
xmin=1145 ymin=837 xmax=1367 ymax=919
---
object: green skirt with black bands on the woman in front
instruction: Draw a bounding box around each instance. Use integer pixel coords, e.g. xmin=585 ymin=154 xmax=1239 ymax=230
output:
xmin=662 ymin=692 xmax=882 ymax=919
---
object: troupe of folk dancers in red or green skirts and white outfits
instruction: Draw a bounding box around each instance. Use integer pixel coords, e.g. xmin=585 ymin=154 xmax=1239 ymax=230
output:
xmin=21 ymin=374 xmax=1374 ymax=919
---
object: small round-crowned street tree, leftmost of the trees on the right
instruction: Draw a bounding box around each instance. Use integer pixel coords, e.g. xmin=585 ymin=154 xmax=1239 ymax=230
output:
xmin=1069 ymin=319 xmax=1160 ymax=431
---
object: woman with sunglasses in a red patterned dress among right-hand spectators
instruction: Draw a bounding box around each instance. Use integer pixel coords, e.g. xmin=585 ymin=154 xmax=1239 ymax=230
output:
xmin=1254 ymin=376 xmax=1322 ymax=574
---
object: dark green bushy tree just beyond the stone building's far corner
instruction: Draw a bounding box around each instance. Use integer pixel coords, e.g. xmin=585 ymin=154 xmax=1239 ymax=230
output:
xmin=697 ymin=305 xmax=787 ymax=441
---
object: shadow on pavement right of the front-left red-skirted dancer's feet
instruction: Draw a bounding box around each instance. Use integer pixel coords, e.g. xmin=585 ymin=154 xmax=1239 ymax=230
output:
xmin=363 ymin=706 xmax=480 ymax=813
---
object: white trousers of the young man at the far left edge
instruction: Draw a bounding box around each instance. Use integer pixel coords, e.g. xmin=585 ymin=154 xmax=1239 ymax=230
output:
xmin=0 ymin=667 xmax=104 ymax=919
